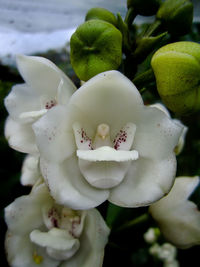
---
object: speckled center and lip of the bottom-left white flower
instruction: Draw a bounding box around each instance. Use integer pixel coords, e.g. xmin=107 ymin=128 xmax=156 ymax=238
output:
xmin=30 ymin=207 xmax=83 ymax=264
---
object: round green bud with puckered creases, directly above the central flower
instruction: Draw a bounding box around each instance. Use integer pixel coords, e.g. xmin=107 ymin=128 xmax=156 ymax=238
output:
xmin=70 ymin=20 xmax=122 ymax=81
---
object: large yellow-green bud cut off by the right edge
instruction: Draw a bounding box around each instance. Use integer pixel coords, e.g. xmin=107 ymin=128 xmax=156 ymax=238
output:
xmin=151 ymin=42 xmax=200 ymax=115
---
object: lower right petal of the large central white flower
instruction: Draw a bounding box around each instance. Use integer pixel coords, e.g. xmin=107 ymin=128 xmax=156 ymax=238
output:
xmin=109 ymin=154 xmax=176 ymax=207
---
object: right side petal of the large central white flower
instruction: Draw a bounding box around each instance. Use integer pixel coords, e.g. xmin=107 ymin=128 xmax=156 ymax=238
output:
xmin=133 ymin=107 xmax=183 ymax=160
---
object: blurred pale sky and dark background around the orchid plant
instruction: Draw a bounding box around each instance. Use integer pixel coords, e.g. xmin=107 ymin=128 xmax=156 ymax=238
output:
xmin=0 ymin=0 xmax=200 ymax=267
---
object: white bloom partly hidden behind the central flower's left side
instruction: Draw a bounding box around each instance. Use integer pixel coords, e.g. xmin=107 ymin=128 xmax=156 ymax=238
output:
xmin=5 ymin=55 xmax=76 ymax=154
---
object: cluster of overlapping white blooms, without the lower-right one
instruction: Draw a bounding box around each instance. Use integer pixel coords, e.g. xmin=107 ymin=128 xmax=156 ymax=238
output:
xmin=5 ymin=56 xmax=200 ymax=267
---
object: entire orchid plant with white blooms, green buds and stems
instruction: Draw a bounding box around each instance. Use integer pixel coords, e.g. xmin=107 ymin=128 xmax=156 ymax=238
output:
xmin=2 ymin=0 xmax=200 ymax=267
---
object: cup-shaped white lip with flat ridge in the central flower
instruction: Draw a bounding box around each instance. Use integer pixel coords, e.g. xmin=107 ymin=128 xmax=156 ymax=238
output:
xmin=77 ymin=146 xmax=138 ymax=189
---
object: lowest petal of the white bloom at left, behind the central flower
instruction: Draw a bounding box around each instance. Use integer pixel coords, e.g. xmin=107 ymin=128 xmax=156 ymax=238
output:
xmin=5 ymin=117 xmax=38 ymax=155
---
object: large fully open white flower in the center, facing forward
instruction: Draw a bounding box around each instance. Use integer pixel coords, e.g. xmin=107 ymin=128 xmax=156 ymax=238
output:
xmin=33 ymin=71 xmax=182 ymax=209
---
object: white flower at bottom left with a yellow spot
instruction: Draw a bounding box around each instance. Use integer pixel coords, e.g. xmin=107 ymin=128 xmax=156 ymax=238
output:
xmin=5 ymin=184 xmax=109 ymax=267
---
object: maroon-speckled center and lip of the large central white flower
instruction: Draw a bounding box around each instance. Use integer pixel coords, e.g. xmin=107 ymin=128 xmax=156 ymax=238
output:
xmin=73 ymin=122 xmax=139 ymax=189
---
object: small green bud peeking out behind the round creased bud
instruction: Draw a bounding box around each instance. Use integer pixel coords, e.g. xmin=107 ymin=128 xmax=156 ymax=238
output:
xmin=85 ymin=7 xmax=117 ymax=26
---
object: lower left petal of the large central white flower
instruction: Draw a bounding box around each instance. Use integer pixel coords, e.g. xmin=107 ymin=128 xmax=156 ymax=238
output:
xmin=41 ymin=156 xmax=109 ymax=210
